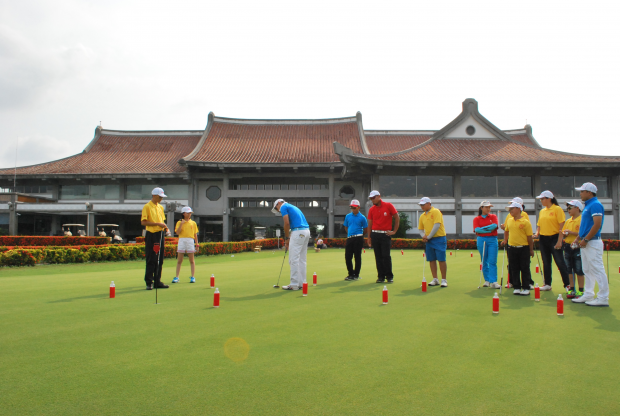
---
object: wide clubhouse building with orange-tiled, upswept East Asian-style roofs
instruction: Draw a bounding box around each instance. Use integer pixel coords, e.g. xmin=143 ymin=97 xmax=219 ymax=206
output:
xmin=0 ymin=99 xmax=620 ymax=241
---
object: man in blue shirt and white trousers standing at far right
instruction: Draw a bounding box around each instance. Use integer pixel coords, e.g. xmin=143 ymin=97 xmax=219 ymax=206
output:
xmin=572 ymin=182 xmax=609 ymax=306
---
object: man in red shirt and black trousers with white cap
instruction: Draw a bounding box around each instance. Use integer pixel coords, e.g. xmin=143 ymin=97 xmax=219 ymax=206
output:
xmin=368 ymin=191 xmax=400 ymax=283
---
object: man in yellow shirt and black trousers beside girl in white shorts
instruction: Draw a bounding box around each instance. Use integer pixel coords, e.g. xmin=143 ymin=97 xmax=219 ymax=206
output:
xmin=141 ymin=188 xmax=170 ymax=290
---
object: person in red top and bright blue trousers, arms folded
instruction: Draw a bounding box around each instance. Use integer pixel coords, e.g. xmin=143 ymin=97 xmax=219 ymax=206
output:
xmin=474 ymin=201 xmax=501 ymax=289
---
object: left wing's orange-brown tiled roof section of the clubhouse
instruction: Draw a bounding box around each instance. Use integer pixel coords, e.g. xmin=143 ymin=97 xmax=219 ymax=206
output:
xmin=0 ymin=130 xmax=201 ymax=175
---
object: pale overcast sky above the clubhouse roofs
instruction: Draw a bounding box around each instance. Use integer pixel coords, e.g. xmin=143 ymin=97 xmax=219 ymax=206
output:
xmin=0 ymin=0 xmax=620 ymax=167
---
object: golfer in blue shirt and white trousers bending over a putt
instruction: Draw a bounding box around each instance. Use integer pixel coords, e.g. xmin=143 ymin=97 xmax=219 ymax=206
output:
xmin=271 ymin=199 xmax=310 ymax=290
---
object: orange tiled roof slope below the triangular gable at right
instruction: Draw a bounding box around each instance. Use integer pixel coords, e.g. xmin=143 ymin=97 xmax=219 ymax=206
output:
xmin=352 ymin=139 xmax=620 ymax=163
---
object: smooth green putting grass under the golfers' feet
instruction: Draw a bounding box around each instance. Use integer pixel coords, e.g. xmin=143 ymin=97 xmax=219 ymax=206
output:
xmin=0 ymin=249 xmax=620 ymax=415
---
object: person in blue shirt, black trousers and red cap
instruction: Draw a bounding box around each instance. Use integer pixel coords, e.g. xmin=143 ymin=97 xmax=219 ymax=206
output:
xmin=343 ymin=199 xmax=368 ymax=280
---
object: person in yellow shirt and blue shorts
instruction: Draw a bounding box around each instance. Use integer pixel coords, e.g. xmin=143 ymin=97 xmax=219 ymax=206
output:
xmin=418 ymin=197 xmax=448 ymax=287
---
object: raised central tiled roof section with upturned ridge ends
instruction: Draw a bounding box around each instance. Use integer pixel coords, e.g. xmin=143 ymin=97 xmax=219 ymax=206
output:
xmin=186 ymin=117 xmax=363 ymax=164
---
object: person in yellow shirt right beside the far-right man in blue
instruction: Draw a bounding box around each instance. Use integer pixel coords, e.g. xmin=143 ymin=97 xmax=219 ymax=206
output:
xmin=562 ymin=199 xmax=583 ymax=299
